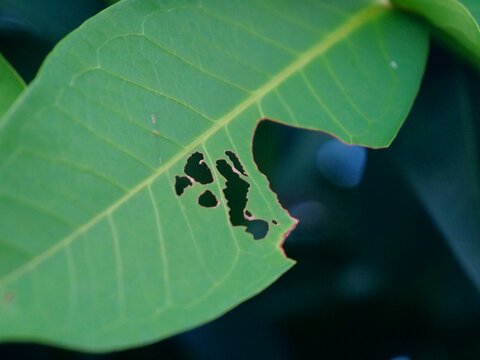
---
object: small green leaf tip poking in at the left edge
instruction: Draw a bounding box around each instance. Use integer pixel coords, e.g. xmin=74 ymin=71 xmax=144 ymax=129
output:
xmin=0 ymin=54 xmax=25 ymax=119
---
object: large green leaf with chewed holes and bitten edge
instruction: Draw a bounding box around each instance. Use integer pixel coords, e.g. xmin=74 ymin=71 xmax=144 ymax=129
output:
xmin=0 ymin=0 xmax=428 ymax=351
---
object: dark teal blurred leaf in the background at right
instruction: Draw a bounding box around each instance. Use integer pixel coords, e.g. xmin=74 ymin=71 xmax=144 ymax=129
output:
xmin=392 ymin=54 xmax=480 ymax=289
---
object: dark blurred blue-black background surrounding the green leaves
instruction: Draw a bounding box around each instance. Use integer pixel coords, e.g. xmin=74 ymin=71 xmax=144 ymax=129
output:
xmin=0 ymin=0 xmax=480 ymax=360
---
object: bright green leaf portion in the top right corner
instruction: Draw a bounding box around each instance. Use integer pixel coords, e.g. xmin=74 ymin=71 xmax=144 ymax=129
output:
xmin=392 ymin=0 xmax=480 ymax=67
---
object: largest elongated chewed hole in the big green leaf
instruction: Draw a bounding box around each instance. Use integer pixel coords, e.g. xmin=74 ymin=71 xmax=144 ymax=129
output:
xmin=216 ymin=159 xmax=268 ymax=240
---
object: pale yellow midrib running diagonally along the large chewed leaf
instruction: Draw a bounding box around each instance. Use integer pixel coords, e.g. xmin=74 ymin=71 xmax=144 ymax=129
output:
xmin=0 ymin=5 xmax=389 ymax=288
